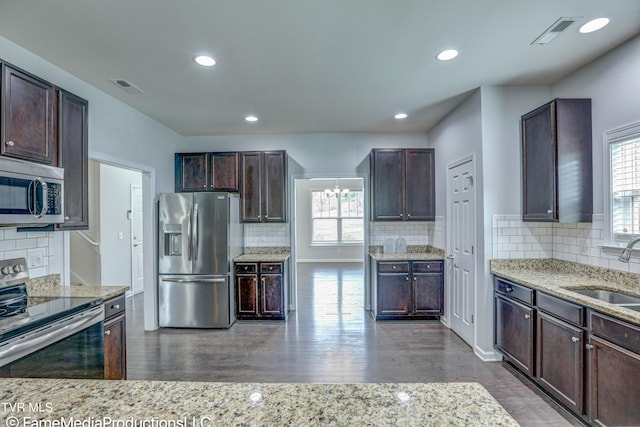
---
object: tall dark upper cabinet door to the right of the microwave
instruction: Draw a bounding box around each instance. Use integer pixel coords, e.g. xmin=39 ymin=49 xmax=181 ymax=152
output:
xmin=58 ymin=90 xmax=89 ymax=230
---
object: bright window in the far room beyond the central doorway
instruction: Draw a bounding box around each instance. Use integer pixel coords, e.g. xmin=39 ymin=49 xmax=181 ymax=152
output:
xmin=311 ymin=190 xmax=364 ymax=244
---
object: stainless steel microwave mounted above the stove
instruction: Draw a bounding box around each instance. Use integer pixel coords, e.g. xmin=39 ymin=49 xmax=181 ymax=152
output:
xmin=0 ymin=156 xmax=64 ymax=226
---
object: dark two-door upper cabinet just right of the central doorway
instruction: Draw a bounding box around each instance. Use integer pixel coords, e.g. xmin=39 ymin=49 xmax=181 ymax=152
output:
xmin=371 ymin=148 xmax=435 ymax=221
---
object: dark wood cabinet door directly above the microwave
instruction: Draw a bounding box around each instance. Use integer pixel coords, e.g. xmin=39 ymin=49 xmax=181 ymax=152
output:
xmin=0 ymin=64 xmax=58 ymax=165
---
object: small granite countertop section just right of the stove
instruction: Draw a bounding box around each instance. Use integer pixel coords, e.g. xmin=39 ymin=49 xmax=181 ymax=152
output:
xmin=27 ymin=274 xmax=129 ymax=300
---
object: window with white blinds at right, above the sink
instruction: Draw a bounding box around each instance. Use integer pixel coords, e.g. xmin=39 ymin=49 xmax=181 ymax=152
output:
xmin=607 ymin=124 xmax=640 ymax=241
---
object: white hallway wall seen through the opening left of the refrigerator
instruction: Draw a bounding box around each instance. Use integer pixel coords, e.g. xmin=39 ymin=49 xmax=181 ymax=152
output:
xmin=100 ymin=164 xmax=142 ymax=287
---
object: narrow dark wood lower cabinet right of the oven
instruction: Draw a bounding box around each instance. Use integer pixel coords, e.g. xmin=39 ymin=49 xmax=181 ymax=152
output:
xmin=104 ymin=295 xmax=127 ymax=380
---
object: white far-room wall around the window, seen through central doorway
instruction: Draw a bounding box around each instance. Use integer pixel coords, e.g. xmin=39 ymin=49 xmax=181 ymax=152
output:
xmin=295 ymin=179 xmax=364 ymax=262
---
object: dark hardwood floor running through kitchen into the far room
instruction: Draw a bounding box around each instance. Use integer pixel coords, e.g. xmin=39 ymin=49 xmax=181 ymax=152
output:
xmin=127 ymin=263 xmax=580 ymax=426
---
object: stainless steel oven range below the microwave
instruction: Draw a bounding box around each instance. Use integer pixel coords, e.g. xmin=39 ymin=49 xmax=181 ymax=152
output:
xmin=0 ymin=259 xmax=104 ymax=379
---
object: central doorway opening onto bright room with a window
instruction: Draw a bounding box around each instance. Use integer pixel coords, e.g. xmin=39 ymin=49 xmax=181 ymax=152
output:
xmin=291 ymin=178 xmax=366 ymax=321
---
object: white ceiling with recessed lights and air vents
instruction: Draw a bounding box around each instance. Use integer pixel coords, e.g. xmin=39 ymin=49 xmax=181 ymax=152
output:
xmin=0 ymin=0 xmax=640 ymax=135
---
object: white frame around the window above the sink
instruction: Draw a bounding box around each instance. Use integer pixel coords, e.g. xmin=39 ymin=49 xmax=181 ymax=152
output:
xmin=603 ymin=122 xmax=640 ymax=247
